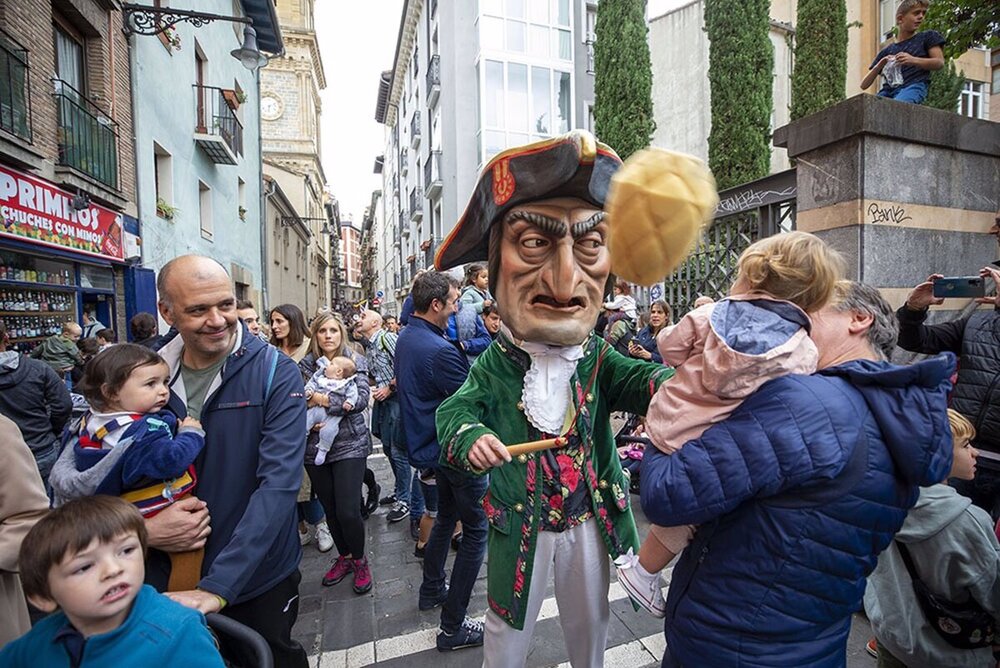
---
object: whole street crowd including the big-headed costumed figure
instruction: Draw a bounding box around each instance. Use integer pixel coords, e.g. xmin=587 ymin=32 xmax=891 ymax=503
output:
xmin=0 ymin=132 xmax=1000 ymax=668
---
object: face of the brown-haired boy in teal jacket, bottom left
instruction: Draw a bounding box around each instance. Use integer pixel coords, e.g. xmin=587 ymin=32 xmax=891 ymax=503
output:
xmin=30 ymin=533 xmax=145 ymax=638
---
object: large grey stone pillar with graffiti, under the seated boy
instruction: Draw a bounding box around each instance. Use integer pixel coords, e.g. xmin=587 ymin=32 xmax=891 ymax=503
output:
xmin=774 ymin=95 xmax=1000 ymax=320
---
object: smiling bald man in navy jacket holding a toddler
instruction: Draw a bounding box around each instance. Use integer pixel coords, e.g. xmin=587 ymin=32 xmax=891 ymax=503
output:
xmin=147 ymin=255 xmax=308 ymax=668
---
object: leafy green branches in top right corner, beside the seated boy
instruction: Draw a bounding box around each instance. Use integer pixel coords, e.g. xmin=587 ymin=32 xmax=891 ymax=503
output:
xmin=920 ymin=0 xmax=1000 ymax=58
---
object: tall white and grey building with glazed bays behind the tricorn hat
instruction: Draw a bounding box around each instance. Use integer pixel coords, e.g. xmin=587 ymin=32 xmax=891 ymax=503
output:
xmin=366 ymin=0 xmax=597 ymax=313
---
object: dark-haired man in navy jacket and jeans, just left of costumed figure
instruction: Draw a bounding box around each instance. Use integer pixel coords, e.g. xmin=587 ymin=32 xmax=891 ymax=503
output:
xmin=395 ymin=271 xmax=487 ymax=651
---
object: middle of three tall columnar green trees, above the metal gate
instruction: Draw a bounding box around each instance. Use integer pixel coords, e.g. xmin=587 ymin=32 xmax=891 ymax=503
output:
xmin=705 ymin=0 xmax=774 ymax=190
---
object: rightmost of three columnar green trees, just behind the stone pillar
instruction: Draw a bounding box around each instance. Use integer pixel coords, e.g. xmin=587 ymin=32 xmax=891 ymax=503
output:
xmin=791 ymin=0 xmax=847 ymax=120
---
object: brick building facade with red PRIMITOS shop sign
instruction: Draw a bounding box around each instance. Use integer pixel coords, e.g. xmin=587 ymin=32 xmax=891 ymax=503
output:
xmin=0 ymin=0 xmax=140 ymax=352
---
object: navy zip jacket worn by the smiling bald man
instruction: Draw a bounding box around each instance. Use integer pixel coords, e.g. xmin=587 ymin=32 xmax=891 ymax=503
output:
xmin=150 ymin=322 xmax=306 ymax=604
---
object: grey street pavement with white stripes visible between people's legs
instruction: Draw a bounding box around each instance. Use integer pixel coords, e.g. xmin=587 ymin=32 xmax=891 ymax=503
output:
xmin=293 ymin=446 xmax=875 ymax=668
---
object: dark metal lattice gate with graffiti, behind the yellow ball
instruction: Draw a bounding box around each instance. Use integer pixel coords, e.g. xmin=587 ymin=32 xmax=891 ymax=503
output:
xmin=664 ymin=169 xmax=795 ymax=318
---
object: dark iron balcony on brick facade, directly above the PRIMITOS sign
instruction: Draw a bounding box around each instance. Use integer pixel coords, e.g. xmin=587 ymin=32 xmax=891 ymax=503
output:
xmin=53 ymin=79 xmax=118 ymax=190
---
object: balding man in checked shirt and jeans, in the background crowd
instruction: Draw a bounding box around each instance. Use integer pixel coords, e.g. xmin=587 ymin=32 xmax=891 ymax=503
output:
xmin=354 ymin=310 xmax=424 ymax=535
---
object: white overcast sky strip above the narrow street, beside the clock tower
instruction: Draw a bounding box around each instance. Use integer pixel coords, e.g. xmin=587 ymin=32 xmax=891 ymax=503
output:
xmin=315 ymin=0 xmax=403 ymax=222
